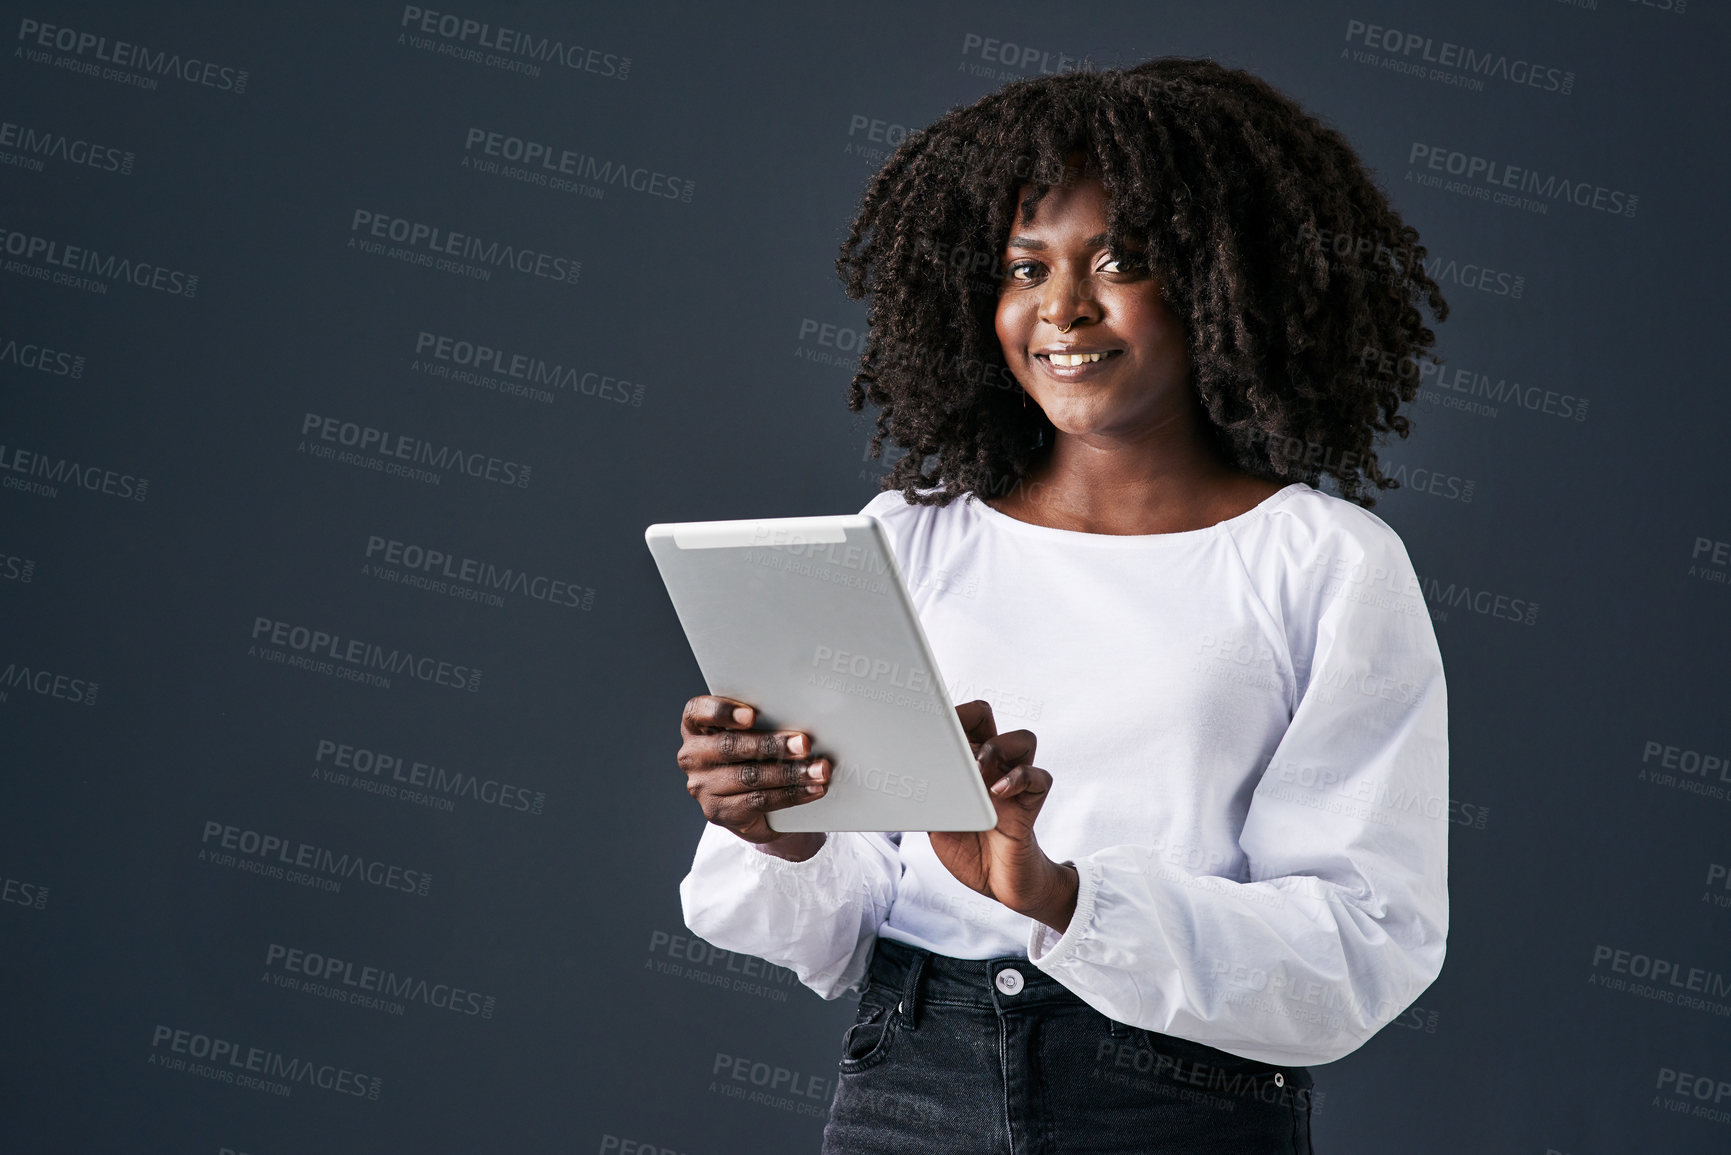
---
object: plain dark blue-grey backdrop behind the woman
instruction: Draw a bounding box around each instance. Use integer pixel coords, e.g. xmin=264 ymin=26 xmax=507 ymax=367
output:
xmin=0 ymin=0 xmax=1731 ymax=1155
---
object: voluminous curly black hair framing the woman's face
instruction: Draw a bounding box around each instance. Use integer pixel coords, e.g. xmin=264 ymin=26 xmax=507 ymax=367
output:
xmin=836 ymin=57 xmax=1449 ymax=507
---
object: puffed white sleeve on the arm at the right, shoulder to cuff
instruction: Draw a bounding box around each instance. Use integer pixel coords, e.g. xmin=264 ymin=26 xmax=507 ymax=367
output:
xmin=1028 ymin=516 xmax=1449 ymax=1065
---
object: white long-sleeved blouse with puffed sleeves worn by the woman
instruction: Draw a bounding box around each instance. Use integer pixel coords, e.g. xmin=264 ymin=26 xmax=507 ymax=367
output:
xmin=679 ymin=483 xmax=1449 ymax=1065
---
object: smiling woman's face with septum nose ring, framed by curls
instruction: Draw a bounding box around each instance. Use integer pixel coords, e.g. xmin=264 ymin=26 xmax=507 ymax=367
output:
xmin=995 ymin=178 xmax=1196 ymax=440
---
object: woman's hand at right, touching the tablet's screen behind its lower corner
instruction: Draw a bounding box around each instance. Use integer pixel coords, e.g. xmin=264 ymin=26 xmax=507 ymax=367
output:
xmin=928 ymin=700 xmax=1077 ymax=933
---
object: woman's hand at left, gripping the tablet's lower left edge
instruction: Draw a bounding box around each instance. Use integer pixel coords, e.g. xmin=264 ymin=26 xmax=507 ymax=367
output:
xmin=679 ymin=694 xmax=831 ymax=861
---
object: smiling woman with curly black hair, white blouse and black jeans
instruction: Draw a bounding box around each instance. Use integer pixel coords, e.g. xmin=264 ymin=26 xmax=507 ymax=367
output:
xmin=679 ymin=59 xmax=1449 ymax=1155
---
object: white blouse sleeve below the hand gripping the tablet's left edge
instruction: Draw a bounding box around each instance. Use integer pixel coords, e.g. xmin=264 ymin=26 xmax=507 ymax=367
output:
xmin=679 ymin=824 xmax=902 ymax=999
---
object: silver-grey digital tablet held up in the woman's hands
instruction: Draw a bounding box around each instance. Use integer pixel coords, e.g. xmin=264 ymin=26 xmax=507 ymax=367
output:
xmin=644 ymin=514 xmax=997 ymax=831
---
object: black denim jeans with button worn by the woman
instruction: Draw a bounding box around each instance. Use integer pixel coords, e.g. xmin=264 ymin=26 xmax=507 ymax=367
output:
xmin=822 ymin=939 xmax=1314 ymax=1155
